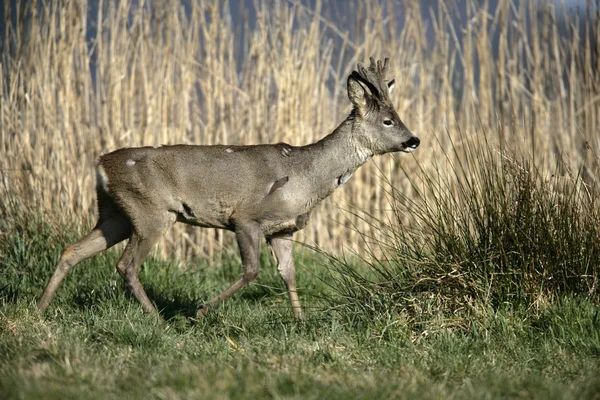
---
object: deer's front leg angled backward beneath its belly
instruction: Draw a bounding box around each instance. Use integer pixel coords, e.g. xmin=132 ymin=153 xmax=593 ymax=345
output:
xmin=197 ymin=222 xmax=262 ymax=317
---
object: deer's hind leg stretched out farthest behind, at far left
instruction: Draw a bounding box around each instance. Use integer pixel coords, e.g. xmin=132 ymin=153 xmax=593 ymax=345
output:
xmin=37 ymin=216 xmax=131 ymax=312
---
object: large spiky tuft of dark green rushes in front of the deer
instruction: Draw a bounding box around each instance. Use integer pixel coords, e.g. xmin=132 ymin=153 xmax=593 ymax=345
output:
xmin=327 ymin=125 xmax=600 ymax=334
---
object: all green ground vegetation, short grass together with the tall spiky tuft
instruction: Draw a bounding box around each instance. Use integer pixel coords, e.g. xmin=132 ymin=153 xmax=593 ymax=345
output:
xmin=0 ymin=127 xmax=600 ymax=399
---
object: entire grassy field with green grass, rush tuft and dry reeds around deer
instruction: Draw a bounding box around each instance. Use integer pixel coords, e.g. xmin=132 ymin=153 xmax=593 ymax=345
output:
xmin=0 ymin=0 xmax=600 ymax=399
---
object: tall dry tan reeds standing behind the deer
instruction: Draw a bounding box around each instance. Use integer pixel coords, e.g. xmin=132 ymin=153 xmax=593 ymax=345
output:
xmin=0 ymin=0 xmax=600 ymax=258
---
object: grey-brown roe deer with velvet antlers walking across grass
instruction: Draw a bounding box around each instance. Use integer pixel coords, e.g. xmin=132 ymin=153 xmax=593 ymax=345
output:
xmin=37 ymin=57 xmax=420 ymax=320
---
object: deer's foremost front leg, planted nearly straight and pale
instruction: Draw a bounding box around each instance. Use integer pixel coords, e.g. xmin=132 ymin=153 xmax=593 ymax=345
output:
xmin=267 ymin=234 xmax=303 ymax=319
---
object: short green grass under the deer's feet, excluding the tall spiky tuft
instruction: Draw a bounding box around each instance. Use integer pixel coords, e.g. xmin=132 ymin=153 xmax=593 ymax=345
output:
xmin=0 ymin=218 xmax=600 ymax=399
